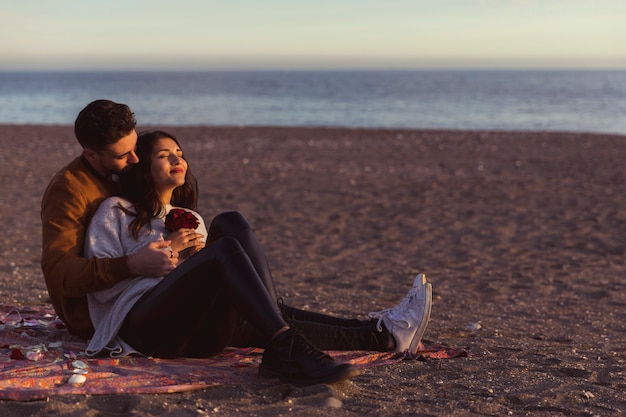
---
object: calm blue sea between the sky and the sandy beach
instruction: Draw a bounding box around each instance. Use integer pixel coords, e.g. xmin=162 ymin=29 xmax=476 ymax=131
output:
xmin=0 ymin=70 xmax=626 ymax=134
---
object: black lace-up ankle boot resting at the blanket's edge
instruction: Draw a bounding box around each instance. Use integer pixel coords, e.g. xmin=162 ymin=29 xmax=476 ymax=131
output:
xmin=259 ymin=329 xmax=359 ymax=385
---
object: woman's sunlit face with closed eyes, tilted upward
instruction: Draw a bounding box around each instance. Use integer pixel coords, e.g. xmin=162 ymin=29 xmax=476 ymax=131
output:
xmin=150 ymin=138 xmax=187 ymax=193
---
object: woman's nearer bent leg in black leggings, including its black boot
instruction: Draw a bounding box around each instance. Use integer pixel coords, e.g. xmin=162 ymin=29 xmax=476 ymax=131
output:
xmin=120 ymin=238 xmax=358 ymax=384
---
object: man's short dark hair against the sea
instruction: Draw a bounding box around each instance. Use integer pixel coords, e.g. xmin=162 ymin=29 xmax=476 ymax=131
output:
xmin=74 ymin=100 xmax=137 ymax=150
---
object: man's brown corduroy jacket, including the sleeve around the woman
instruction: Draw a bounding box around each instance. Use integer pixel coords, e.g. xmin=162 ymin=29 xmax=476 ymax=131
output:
xmin=41 ymin=157 xmax=131 ymax=338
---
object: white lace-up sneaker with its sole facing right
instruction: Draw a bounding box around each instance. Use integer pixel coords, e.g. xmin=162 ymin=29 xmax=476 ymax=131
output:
xmin=368 ymin=274 xmax=433 ymax=354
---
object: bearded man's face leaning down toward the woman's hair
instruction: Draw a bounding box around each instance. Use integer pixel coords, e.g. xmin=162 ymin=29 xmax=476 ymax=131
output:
xmin=83 ymin=130 xmax=139 ymax=177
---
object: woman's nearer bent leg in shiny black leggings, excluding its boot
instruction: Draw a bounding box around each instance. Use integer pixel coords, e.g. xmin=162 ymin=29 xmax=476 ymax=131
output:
xmin=121 ymin=234 xmax=287 ymax=357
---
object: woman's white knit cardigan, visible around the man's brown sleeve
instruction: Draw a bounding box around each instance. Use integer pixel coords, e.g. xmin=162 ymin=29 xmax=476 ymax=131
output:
xmin=80 ymin=197 xmax=207 ymax=357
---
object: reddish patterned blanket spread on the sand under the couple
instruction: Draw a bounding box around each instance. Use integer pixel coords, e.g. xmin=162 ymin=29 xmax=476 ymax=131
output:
xmin=0 ymin=306 xmax=468 ymax=401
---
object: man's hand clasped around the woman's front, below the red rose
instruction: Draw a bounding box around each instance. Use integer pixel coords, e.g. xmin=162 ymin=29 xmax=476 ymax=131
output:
xmin=127 ymin=240 xmax=178 ymax=277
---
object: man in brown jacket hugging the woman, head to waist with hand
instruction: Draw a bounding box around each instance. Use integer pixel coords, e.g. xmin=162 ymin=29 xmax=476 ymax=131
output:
xmin=41 ymin=100 xmax=177 ymax=338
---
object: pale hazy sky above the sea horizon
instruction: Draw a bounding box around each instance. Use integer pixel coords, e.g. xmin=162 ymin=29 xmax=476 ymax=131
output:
xmin=0 ymin=0 xmax=626 ymax=70
